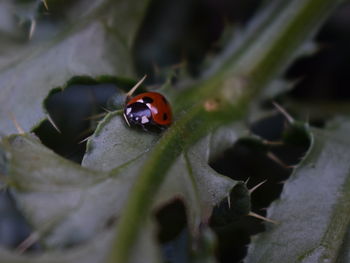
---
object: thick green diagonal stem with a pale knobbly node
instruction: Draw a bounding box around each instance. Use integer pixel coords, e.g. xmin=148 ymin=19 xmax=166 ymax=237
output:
xmin=108 ymin=0 xmax=342 ymax=263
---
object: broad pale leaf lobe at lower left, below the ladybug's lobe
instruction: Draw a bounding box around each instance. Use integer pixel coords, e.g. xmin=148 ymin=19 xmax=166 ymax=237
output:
xmin=7 ymin=136 xmax=136 ymax=249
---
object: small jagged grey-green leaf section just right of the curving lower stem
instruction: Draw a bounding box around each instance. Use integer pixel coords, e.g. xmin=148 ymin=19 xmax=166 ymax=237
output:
xmin=156 ymin=124 xmax=244 ymax=233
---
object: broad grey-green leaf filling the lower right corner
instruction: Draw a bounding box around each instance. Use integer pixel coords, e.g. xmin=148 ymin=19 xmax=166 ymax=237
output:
xmin=245 ymin=119 xmax=350 ymax=262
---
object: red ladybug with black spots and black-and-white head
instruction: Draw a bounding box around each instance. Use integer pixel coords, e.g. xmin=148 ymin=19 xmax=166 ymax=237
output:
xmin=123 ymin=78 xmax=172 ymax=131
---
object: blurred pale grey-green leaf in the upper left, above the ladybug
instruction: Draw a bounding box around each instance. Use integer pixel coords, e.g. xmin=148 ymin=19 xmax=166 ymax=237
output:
xmin=0 ymin=0 xmax=147 ymax=134
